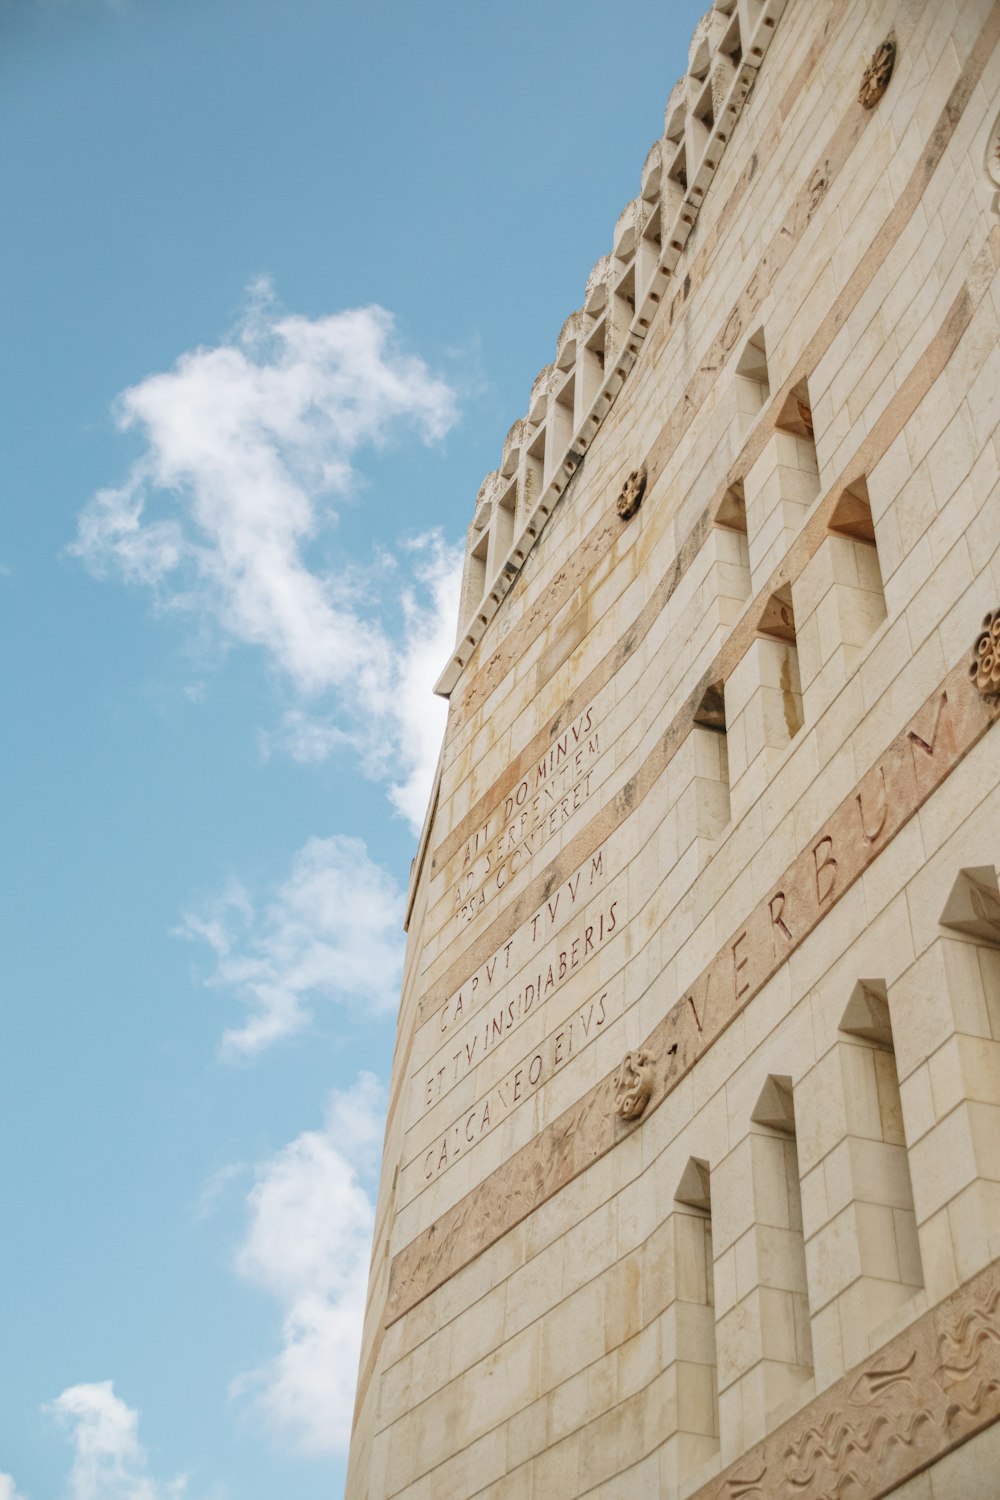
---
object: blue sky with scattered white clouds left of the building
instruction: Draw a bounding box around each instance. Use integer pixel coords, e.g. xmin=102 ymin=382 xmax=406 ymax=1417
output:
xmin=0 ymin=0 xmax=700 ymax=1500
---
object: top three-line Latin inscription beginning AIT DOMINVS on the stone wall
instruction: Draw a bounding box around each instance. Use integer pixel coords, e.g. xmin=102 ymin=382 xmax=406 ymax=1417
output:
xmin=453 ymin=705 xmax=601 ymax=923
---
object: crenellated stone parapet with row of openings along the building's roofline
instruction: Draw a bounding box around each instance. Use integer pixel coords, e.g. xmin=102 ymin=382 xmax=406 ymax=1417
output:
xmin=436 ymin=0 xmax=787 ymax=698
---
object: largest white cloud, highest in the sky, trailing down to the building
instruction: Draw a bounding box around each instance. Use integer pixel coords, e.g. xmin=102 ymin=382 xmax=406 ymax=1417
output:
xmin=70 ymin=282 xmax=460 ymax=825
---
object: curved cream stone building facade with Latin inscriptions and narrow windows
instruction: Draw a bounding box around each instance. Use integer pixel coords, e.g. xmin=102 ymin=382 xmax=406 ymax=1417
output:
xmin=346 ymin=0 xmax=1000 ymax=1500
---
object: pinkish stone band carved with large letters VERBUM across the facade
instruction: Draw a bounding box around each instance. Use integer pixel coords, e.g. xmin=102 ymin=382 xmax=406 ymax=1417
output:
xmin=385 ymin=663 xmax=1000 ymax=1323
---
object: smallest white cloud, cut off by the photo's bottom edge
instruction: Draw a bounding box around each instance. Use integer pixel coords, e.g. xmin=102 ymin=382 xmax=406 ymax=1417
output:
xmin=46 ymin=1380 xmax=187 ymax=1500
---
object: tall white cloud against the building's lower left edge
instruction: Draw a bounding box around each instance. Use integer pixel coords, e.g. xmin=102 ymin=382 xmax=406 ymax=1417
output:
xmin=234 ymin=1073 xmax=384 ymax=1454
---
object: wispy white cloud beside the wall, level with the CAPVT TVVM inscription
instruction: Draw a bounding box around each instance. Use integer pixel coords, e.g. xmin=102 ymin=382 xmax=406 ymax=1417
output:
xmin=178 ymin=836 xmax=403 ymax=1058
